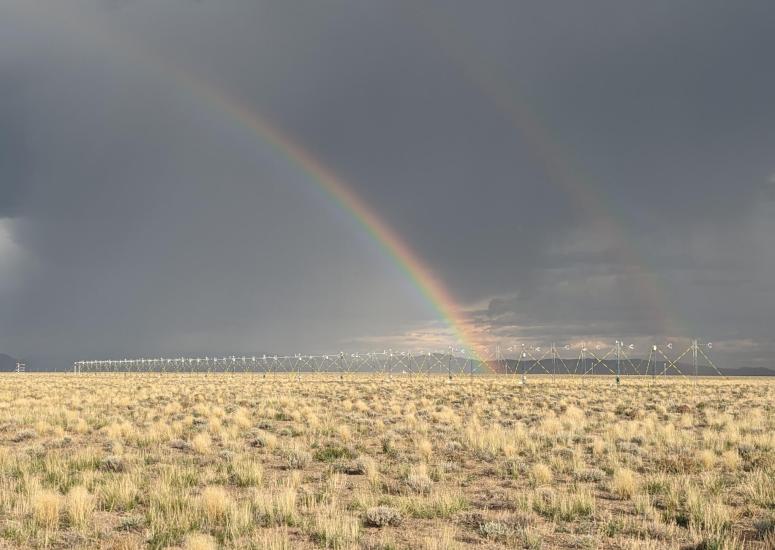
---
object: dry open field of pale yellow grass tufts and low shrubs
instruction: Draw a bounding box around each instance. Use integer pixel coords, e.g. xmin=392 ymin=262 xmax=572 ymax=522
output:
xmin=0 ymin=374 xmax=775 ymax=549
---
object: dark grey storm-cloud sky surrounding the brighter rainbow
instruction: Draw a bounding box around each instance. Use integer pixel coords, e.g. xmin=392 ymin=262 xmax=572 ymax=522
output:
xmin=0 ymin=0 xmax=775 ymax=366
